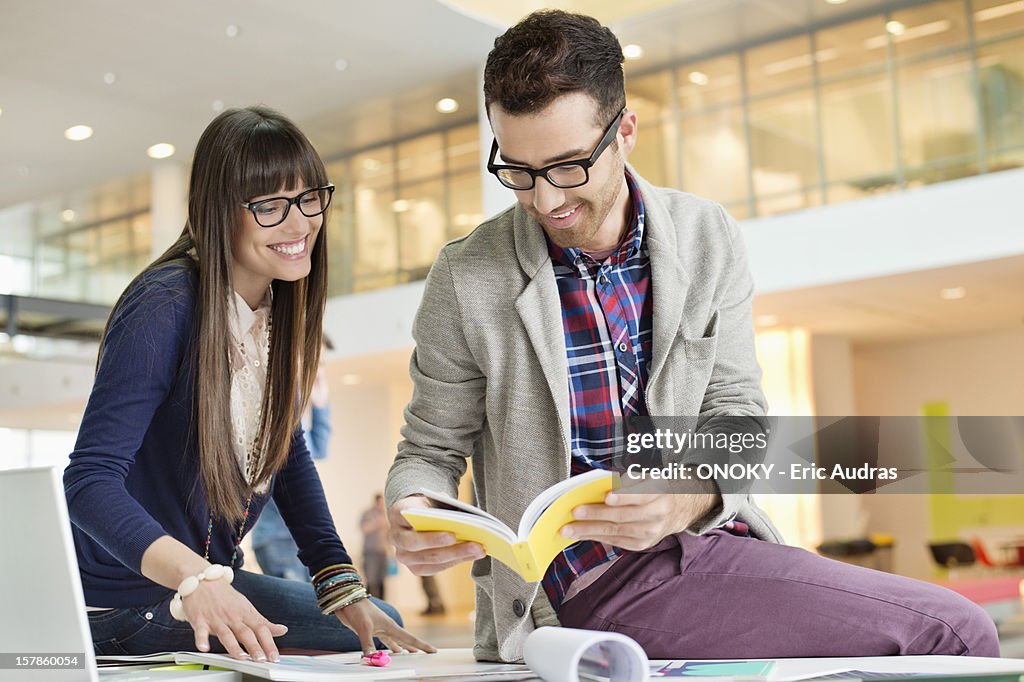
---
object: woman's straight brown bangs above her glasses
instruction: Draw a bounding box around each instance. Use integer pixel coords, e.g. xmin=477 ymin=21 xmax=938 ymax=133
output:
xmin=234 ymin=119 xmax=327 ymax=201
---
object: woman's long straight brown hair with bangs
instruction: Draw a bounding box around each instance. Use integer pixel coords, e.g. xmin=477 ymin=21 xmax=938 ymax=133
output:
xmin=99 ymin=106 xmax=328 ymax=522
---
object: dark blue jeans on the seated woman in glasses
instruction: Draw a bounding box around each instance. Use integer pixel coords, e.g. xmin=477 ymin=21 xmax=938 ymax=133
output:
xmin=89 ymin=570 xmax=402 ymax=655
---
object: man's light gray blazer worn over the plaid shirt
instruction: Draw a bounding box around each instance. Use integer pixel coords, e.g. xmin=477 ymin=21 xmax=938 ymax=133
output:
xmin=385 ymin=169 xmax=780 ymax=662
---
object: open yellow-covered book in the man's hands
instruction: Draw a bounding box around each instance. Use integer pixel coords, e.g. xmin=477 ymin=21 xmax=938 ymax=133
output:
xmin=401 ymin=469 xmax=618 ymax=583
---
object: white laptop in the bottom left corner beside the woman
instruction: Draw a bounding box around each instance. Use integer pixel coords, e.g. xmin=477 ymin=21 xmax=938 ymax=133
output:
xmin=0 ymin=467 xmax=234 ymax=682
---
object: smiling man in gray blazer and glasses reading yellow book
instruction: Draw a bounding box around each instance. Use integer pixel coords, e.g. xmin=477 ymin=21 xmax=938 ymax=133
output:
xmin=386 ymin=10 xmax=998 ymax=660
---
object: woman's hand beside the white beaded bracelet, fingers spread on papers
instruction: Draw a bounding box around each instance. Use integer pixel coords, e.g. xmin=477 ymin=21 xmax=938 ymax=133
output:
xmin=181 ymin=581 xmax=288 ymax=663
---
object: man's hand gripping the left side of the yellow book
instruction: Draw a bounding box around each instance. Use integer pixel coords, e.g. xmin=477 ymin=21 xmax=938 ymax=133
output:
xmin=387 ymin=495 xmax=484 ymax=576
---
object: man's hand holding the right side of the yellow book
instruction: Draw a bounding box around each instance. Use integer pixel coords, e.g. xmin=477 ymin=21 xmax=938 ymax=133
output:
xmin=561 ymin=483 xmax=721 ymax=550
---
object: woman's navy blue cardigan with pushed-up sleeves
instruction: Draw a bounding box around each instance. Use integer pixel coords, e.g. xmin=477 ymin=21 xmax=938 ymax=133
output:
xmin=65 ymin=263 xmax=351 ymax=608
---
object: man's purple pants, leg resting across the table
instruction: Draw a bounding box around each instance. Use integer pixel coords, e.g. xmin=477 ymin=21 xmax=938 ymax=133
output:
xmin=558 ymin=530 xmax=999 ymax=658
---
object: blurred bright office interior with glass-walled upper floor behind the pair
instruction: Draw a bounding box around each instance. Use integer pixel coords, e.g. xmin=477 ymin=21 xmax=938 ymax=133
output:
xmin=0 ymin=0 xmax=1024 ymax=611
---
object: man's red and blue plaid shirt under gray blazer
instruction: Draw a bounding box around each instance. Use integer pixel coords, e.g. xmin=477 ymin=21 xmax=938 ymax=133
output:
xmin=542 ymin=173 xmax=653 ymax=610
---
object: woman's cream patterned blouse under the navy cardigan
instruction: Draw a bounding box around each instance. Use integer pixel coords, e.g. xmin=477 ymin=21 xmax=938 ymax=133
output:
xmin=228 ymin=289 xmax=270 ymax=495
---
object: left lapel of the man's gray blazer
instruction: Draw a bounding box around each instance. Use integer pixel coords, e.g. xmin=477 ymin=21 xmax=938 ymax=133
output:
xmin=514 ymin=201 xmax=570 ymax=456
